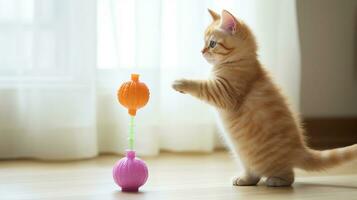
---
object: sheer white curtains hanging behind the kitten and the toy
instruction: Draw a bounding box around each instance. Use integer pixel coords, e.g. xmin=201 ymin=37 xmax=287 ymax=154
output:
xmin=0 ymin=0 xmax=300 ymax=159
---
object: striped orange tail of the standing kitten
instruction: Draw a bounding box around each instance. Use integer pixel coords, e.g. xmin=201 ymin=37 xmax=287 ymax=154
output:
xmin=296 ymin=144 xmax=357 ymax=171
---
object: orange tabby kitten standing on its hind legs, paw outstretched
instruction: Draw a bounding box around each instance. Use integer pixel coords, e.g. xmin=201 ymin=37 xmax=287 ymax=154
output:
xmin=173 ymin=10 xmax=357 ymax=186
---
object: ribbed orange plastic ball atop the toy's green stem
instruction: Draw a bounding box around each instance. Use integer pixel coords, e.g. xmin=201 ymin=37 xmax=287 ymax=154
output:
xmin=117 ymin=74 xmax=150 ymax=116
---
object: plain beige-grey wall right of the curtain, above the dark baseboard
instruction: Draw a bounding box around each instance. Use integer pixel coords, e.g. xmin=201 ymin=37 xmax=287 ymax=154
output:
xmin=297 ymin=0 xmax=357 ymax=117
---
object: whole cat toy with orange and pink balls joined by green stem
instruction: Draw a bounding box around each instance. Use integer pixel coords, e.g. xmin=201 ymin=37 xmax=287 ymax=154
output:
xmin=113 ymin=74 xmax=149 ymax=192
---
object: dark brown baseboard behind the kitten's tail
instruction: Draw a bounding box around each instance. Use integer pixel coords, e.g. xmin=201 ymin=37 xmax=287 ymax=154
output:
xmin=304 ymin=117 xmax=357 ymax=149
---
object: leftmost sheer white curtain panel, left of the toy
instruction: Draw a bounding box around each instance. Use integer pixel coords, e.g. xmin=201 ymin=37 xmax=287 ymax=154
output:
xmin=0 ymin=0 xmax=98 ymax=159
